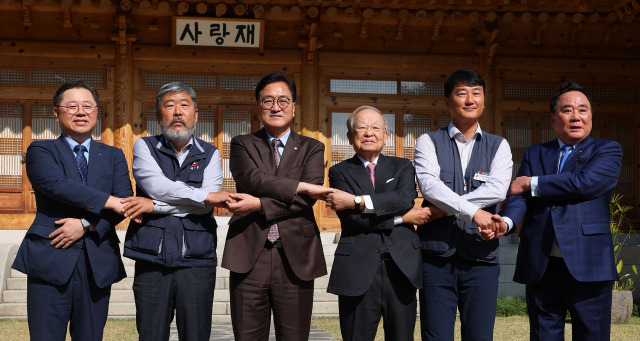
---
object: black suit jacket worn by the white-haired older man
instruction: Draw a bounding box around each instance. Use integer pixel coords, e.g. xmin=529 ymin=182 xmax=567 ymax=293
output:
xmin=327 ymin=155 xmax=422 ymax=296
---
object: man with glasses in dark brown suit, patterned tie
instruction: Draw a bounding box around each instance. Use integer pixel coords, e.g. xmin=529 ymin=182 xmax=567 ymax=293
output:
xmin=222 ymin=72 xmax=331 ymax=341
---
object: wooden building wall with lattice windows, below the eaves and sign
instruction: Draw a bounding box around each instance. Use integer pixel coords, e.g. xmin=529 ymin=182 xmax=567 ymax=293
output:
xmin=0 ymin=40 xmax=640 ymax=230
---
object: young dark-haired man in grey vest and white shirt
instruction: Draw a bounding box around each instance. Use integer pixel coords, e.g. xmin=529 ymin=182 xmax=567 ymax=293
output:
xmin=415 ymin=69 xmax=513 ymax=341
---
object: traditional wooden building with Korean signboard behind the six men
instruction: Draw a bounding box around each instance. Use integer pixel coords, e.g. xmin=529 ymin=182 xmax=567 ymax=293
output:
xmin=0 ymin=0 xmax=640 ymax=229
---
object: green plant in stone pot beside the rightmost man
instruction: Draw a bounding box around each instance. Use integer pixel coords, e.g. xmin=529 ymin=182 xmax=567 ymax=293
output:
xmin=609 ymin=194 xmax=638 ymax=323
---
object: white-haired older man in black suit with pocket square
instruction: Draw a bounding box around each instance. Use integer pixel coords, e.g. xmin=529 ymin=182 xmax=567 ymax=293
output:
xmin=325 ymin=106 xmax=430 ymax=341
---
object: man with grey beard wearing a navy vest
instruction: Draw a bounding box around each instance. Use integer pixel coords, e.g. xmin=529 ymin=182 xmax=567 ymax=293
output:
xmin=123 ymin=82 xmax=229 ymax=341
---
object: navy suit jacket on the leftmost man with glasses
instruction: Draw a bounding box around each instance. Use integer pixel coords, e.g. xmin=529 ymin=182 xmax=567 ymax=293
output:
xmin=12 ymin=136 xmax=133 ymax=288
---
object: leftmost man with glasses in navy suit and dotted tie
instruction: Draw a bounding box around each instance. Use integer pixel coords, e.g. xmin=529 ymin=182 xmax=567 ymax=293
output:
xmin=12 ymin=81 xmax=133 ymax=340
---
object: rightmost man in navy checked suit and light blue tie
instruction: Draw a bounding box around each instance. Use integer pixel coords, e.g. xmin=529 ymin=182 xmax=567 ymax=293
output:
xmin=501 ymin=82 xmax=622 ymax=340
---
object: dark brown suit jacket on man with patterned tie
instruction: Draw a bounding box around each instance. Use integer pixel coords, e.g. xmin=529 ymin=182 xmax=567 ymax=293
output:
xmin=222 ymin=129 xmax=327 ymax=280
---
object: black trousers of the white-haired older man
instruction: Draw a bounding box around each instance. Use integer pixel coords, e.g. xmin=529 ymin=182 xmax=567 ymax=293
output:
xmin=338 ymin=259 xmax=417 ymax=341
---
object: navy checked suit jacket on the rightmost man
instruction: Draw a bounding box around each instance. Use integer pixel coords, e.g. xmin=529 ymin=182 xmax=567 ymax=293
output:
xmin=501 ymin=137 xmax=622 ymax=284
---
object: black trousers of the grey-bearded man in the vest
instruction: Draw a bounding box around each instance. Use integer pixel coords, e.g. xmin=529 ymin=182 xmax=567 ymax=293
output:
xmin=133 ymin=261 xmax=216 ymax=341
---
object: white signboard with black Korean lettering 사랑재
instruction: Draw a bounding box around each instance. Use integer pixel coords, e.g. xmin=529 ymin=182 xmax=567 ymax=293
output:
xmin=172 ymin=17 xmax=264 ymax=52
